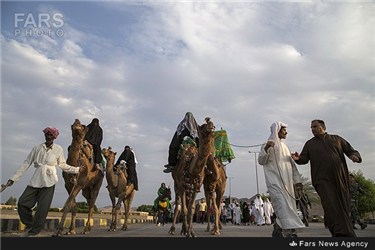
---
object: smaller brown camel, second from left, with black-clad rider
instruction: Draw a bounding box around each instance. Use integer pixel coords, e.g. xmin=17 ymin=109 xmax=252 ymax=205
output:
xmin=102 ymin=147 xmax=135 ymax=231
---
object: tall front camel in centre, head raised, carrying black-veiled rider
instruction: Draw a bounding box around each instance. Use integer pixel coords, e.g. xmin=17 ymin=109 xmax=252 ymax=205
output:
xmin=168 ymin=117 xmax=215 ymax=237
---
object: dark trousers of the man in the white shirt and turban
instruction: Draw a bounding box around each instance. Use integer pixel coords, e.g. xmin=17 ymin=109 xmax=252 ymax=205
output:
xmin=17 ymin=185 xmax=55 ymax=234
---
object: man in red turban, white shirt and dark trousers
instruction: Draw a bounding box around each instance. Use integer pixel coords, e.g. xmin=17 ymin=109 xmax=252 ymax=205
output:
xmin=2 ymin=127 xmax=84 ymax=237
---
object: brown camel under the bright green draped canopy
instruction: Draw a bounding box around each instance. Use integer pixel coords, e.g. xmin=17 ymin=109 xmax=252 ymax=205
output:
xmin=203 ymin=155 xmax=227 ymax=235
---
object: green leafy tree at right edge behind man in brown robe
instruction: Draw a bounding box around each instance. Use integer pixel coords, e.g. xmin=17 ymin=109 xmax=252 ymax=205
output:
xmin=351 ymin=170 xmax=375 ymax=217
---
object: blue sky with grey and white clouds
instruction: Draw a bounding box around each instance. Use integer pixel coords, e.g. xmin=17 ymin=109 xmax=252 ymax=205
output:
xmin=0 ymin=1 xmax=375 ymax=208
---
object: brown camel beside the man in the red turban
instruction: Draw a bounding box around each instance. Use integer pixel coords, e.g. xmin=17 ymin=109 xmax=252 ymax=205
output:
xmin=53 ymin=119 xmax=104 ymax=236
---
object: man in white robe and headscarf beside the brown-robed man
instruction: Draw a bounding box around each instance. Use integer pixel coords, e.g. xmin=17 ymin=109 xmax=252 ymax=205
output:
xmin=258 ymin=122 xmax=305 ymax=237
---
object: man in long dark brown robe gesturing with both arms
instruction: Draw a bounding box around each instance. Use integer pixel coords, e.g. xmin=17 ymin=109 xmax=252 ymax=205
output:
xmin=292 ymin=120 xmax=362 ymax=237
